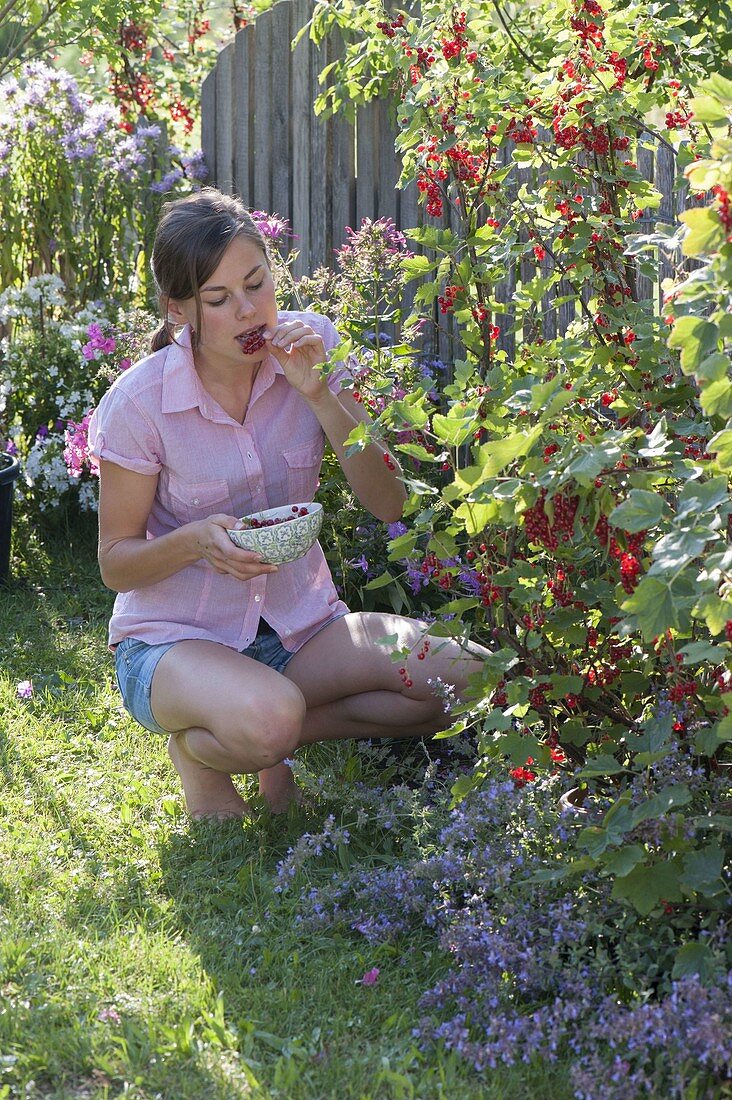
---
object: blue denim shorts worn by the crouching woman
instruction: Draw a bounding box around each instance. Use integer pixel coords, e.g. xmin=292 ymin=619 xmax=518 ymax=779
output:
xmin=114 ymin=619 xmax=295 ymax=735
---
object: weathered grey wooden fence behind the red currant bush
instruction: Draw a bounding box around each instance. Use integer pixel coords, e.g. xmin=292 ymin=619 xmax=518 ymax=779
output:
xmin=201 ymin=0 xmax=688 ymax=359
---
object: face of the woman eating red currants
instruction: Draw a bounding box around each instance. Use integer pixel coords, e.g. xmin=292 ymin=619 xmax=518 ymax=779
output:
xmin=168 ymin=237 xmax=277 ymax=367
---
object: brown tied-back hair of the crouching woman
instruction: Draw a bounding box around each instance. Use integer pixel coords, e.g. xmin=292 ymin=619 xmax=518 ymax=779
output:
xmin=151 ymin=187 xmax=270 ymax=351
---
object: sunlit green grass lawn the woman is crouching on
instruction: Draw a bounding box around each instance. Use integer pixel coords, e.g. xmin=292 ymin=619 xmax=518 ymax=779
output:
xmin=0 ymin=517 xmax=570 ymax=1100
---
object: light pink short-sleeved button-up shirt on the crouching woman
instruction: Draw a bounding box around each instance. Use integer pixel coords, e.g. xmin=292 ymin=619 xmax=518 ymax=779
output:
xmin=89 ymin=312 xmax=348 ymax=652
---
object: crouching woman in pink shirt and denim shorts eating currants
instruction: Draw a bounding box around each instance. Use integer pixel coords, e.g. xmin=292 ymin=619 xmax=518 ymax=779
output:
xmin=89 ymin=189 xmax=483 ymax=817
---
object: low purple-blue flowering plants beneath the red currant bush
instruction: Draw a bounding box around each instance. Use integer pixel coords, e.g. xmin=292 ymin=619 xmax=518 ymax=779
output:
xmin=283 ymin=779 xmax=732 ymax=1100
